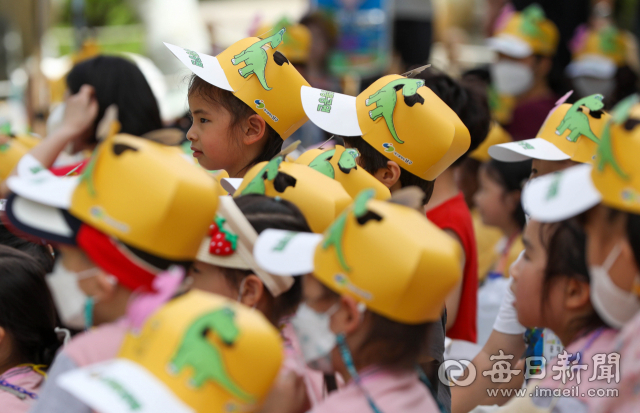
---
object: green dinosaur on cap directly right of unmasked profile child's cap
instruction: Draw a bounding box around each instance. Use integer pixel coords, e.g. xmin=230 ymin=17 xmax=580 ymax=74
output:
xmin=365 ymin=78 xmax=424 ymax=143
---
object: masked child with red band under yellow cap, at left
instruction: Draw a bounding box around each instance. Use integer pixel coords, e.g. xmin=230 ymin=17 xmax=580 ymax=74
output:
xmin=1 ymin=135 xmax=218 ymax=412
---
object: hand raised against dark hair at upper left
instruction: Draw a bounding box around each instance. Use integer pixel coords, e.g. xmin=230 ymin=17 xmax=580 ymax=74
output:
xmin=61 ymin=85 xmax=98 ymax=138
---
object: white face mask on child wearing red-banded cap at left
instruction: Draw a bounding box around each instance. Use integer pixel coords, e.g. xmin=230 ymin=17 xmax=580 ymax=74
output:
xmin=46 ymin=260 xmax=98 ymax=330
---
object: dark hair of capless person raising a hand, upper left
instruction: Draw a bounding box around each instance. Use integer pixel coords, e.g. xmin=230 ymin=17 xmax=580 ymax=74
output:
xmin=67 ymin=56 xmax=162 ymax=142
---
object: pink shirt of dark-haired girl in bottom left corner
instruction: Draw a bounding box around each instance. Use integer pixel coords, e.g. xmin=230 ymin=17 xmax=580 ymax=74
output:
xmin=0 ymin=366 xmax=44 ymax=413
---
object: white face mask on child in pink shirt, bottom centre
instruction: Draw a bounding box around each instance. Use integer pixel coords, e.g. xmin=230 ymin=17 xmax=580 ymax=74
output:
xmin=291 ymin=303 xmax=340 ymax=373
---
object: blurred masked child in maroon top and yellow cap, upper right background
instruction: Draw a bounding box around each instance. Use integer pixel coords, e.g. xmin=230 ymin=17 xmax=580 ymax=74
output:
xmin=488 ymin=4 xmax=559 ymax=141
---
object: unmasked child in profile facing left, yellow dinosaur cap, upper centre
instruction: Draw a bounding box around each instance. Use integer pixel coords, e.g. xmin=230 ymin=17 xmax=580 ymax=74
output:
xmin=166 ymin=28 xmax=309 ymax=178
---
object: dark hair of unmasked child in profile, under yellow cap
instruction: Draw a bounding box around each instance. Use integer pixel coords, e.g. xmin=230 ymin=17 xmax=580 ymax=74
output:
xmin=189 ymin=75 xmax=282 ymax=170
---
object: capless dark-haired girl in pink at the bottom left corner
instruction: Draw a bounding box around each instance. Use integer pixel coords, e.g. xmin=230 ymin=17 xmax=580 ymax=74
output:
xmin=0 ymin=245 xmax=60 ymax=413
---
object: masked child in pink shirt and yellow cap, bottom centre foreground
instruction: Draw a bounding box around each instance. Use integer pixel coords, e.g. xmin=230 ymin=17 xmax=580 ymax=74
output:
xmin=254 ymin=190 xmax=461 ymax=413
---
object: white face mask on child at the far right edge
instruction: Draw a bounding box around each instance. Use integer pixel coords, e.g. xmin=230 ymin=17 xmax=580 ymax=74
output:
xmin=589 ymin=245 xmax=640 ymax=328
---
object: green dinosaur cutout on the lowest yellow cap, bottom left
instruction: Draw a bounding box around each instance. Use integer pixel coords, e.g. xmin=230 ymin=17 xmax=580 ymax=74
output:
xmin=169 ymin=307 xmax=254 ymax=402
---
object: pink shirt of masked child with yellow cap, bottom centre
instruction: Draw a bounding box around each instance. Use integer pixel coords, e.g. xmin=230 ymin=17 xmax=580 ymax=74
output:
xmin=312 ymin=369 xmax=440 ymax=413
